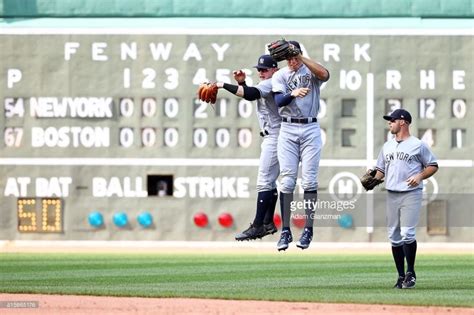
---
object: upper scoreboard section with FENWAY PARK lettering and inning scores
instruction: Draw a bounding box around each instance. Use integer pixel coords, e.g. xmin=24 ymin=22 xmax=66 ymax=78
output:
xmin=0 ymin=34 xmax=472 ymax=158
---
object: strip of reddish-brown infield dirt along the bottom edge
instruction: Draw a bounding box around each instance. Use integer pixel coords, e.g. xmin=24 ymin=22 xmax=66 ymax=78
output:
xmin=0 ymin=294 xmax=474 ymax=315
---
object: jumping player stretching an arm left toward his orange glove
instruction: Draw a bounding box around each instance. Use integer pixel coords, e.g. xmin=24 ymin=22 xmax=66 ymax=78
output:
xmin=216 ymin=55 xmax=281 ymax=241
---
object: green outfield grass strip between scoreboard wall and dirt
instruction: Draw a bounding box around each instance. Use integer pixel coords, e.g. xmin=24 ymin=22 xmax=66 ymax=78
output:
xmin=0 ymin=251 xmax=474 ymax=307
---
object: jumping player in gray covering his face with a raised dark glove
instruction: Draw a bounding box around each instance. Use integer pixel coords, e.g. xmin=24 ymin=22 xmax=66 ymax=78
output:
xmin=272 ymin=41 xmax=329 ymax=251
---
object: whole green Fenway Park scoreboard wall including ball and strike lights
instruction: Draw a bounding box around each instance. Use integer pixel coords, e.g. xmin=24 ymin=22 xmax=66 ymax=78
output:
xmin=0 ymin=30 xmax=474 ymax=240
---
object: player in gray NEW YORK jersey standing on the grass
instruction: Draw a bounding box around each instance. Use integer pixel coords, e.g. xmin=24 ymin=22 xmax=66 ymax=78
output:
xmin=374 ymin=109 xmax=438 ymax=289
